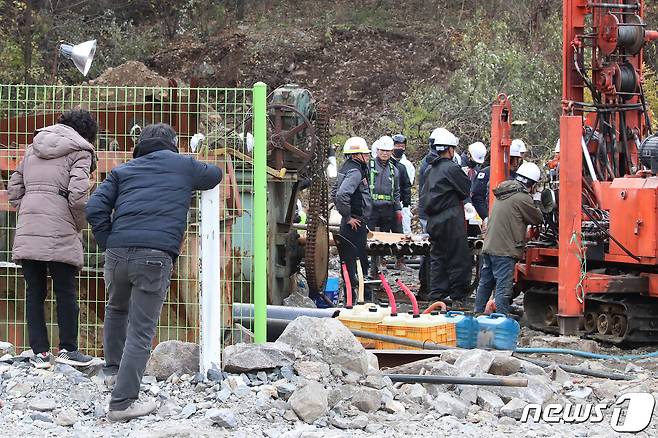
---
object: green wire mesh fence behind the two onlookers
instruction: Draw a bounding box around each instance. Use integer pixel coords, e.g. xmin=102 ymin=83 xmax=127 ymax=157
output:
xmin=0 ymin=82 xmax=264 ymax=356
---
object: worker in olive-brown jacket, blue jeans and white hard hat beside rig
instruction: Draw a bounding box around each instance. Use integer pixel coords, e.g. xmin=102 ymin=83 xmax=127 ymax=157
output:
xmin=475 ymin=162 xmax=543 ymax=314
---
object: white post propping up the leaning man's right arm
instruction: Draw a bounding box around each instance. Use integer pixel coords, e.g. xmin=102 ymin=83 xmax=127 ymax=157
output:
xmin=199 ymin=185 xmax=222 ymax=376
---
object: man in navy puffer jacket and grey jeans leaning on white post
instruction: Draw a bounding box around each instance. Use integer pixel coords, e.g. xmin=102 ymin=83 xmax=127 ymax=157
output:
xmin=86 ymin=123 xmax=222 ymax=421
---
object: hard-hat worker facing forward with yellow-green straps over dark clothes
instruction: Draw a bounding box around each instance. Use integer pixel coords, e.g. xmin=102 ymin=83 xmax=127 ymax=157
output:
xmin=368 ymin=135 xmax=402 ymax=277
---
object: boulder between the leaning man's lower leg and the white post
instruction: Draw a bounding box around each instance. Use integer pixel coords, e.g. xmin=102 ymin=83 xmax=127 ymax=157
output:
xmin=145 ymin=341 xmax=199 ymax=380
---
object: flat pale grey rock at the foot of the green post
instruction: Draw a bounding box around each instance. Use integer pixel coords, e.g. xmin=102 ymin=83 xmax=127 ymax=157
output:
xmin=223 ymin=342 xmax=295 ymax=373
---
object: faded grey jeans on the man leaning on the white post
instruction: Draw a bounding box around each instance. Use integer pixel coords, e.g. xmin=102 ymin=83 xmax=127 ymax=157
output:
xmin=103 ymin=248 xmax=172 ymax=410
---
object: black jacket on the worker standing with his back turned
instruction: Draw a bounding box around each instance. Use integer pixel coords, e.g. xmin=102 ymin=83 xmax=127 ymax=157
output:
xmin=421 ymin=157 xmax=471 ymax=217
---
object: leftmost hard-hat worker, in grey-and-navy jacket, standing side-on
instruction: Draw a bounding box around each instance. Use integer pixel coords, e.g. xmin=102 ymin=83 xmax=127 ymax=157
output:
xmin=331 ymin=137 xmax=372 ymax=302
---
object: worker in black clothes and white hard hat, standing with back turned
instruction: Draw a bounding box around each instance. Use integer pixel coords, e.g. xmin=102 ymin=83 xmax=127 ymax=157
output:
xmin=421 ymin=128 xmax=471 ymax=302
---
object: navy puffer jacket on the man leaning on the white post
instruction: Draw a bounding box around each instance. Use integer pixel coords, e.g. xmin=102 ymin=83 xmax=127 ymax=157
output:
xmin=86 ymin=142 xmax=222 ymax=258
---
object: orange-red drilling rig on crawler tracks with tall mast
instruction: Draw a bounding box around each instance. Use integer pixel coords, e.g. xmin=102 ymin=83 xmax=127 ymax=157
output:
xmin=490 ymin=0 xmax=658 ymax=344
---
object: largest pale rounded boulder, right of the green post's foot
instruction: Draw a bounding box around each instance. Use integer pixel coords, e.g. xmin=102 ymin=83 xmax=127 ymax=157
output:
xmin=276 ymin=316 xmax=369 ymax=375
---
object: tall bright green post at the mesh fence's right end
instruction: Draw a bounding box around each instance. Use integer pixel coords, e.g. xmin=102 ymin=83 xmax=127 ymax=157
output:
xmin=253 ymin=82 xmax=267 ymax=344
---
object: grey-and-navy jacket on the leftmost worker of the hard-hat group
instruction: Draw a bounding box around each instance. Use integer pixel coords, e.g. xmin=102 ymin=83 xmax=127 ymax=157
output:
xmin=331 ymin=158 xmax=372 ymax=222
